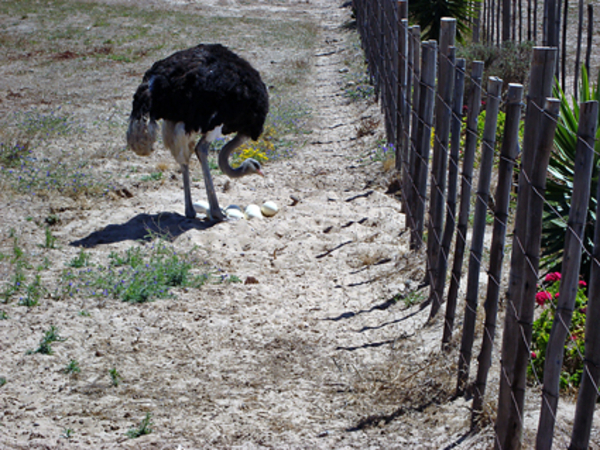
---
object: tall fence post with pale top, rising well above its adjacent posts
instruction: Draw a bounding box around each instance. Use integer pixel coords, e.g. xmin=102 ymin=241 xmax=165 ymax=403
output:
xmin=427 ymin=17 xmax=456 ymax=309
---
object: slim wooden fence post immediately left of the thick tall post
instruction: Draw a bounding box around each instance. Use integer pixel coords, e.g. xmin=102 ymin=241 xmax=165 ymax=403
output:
xmin=473 ymin=84 xmax=523 ymax=424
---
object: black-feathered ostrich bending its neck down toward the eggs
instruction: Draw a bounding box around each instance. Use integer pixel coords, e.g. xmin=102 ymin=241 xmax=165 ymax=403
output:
xmin=127 ymin=44 xmax=269 ymax=221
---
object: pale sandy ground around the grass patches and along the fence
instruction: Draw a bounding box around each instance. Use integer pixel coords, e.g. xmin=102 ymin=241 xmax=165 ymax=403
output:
xmin=0 ymin=0 xmax=600 ymax=449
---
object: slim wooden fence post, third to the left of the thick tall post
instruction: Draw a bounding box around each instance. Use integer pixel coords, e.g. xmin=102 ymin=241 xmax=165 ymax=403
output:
xmin=442 ymin=61 xmax=483 ymax=346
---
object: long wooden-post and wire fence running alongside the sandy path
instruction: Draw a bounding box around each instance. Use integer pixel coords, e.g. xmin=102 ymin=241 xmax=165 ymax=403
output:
xmin=354 ymin=0 xmax=600 ymax=449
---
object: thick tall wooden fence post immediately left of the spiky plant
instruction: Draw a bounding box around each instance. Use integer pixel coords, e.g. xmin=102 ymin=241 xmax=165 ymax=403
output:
xmin=495 ymin=47 xmax=557 ymax=450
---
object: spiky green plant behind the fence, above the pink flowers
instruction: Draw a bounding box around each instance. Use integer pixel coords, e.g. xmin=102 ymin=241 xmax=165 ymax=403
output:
xmin=541 ymin=67 xmax=600 ymax=279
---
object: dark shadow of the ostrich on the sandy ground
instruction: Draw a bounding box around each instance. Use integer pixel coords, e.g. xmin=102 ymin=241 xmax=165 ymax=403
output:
xmin=69 ymin=212 xmax=214 ymax=248
